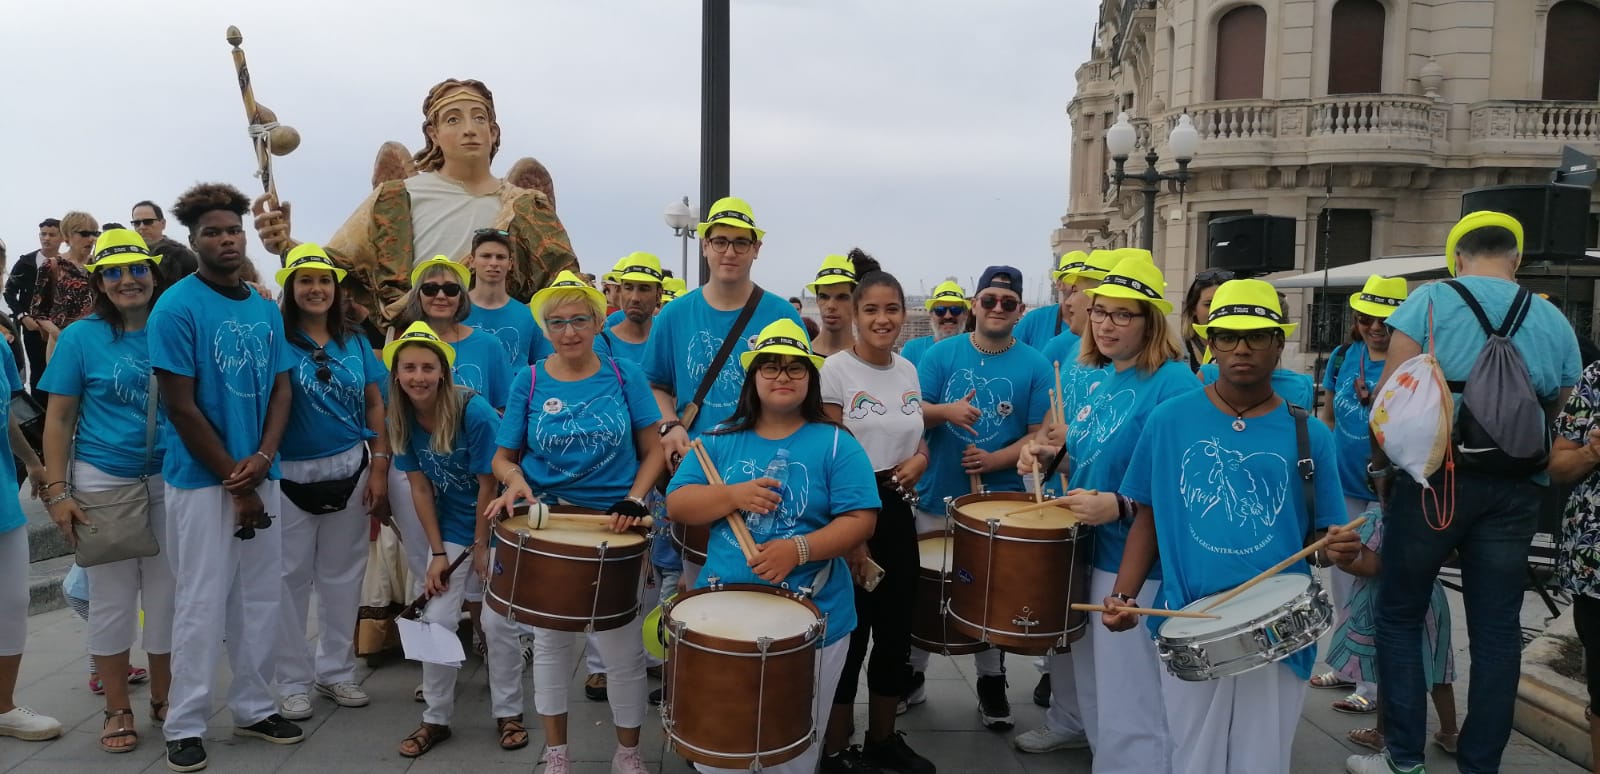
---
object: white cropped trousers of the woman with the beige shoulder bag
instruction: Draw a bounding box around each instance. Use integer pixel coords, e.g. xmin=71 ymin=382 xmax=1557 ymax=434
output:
xmin=72 ymin=461 xmax=178 ymax=656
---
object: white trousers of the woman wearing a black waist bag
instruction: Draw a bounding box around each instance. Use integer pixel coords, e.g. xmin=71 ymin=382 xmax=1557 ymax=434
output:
xmin=277 ymin=443 xmax=371 ymax=696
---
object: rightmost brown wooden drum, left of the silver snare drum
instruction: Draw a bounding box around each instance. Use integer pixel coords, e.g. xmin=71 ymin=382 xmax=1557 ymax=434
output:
xmin=949 ymin=493 xmax=1093 ymax=656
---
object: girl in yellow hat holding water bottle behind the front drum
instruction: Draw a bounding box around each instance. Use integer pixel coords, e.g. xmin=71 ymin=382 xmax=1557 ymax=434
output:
xmin=667 ymin=320 xmax=880 ymax=774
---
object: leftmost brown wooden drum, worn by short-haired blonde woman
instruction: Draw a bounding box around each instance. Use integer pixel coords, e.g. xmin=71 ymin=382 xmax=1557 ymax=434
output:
xmin=483 ymin=505 xmax=650 ymax=632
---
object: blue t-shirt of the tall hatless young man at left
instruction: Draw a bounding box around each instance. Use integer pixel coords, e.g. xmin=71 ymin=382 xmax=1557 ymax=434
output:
xmin=146 ymin=273 xmax=294 ymax=489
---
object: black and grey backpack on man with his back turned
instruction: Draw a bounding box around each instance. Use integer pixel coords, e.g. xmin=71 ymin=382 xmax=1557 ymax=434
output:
xmin=1445 ymin=280 xmax=1550 ymax=478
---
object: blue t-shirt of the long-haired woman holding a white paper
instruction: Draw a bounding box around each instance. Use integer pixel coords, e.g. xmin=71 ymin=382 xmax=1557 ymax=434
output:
xmin=395 ymin=395 xmax=499 ymax=545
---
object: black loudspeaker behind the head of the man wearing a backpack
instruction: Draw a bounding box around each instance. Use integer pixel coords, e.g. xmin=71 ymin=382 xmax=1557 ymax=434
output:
xmin=1461 ymin=182 xmax=1589 ymax=261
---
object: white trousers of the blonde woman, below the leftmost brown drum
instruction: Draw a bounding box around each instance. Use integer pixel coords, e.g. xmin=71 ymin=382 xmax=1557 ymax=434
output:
xmin=528 ymin=616 xmax=646 ymax=728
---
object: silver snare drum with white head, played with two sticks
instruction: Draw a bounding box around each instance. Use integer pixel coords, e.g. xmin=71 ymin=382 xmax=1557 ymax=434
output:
xmin=1155 ymin=574 xmax=1333 ymax=681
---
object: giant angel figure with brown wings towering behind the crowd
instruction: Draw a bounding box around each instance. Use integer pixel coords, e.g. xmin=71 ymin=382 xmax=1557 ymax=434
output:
xmin=254 ymin=80 xmax=578 ymax=321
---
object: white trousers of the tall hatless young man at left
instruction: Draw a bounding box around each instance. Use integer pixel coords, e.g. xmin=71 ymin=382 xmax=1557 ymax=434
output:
xmin=162 ymin=481 xmax=283 ymax=742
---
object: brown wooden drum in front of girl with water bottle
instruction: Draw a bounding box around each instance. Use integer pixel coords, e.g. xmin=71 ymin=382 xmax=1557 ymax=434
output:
xmin=661 ymin=584 xmax=826 ymax=769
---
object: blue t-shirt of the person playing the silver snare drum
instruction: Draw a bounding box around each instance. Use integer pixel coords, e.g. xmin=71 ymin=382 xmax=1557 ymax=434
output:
xmin=1118 ymin=390 xmax=1346 ymax=680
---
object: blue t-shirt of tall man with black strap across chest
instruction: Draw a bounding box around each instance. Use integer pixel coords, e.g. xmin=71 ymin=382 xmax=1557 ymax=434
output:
xmin=642 ymin=288 xmax=805 ymax=437
